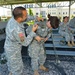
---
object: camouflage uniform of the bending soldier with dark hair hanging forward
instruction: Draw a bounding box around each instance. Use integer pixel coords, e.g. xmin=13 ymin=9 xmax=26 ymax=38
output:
xmin=26 ymin=21 xmax=51 ymax=71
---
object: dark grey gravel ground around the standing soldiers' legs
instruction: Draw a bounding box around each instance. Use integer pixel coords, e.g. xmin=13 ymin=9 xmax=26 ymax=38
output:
xmin=0 ymin=56 xmax=75 ymax=75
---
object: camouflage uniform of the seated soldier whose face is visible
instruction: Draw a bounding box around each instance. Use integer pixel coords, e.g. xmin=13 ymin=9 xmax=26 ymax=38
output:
xmin=59 ymin=22 xmax=74 ymax=42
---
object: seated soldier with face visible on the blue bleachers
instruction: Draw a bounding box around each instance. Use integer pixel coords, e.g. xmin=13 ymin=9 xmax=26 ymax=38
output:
xmin=59 ymin=16 xmax=75 ymax=47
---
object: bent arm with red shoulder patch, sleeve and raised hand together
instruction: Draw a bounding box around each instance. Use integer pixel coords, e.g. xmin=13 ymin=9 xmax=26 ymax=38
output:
xmin=13 ymin=26 xmax=37 ymax=46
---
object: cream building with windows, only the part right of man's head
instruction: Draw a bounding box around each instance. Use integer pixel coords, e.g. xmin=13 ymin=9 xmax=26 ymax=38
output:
xmin=24 ymin=4 xmax=75 ymax=20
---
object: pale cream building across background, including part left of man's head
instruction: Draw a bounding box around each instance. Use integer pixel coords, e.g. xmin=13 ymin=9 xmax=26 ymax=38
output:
xmin=0 ymin=4 xmax=75 ymax=20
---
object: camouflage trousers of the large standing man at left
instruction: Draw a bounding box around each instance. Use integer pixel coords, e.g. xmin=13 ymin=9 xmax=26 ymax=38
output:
xmin=5 ymin=47 xmax=23 ymax=75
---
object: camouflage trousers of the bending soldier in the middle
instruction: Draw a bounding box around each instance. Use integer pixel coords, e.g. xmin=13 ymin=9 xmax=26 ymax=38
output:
xmin=28 ymin=43 xmax=46 ymax=71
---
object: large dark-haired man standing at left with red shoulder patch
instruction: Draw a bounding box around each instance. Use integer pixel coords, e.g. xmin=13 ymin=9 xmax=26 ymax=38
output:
xmin=4 ymin=7 xmax=41 ymax=75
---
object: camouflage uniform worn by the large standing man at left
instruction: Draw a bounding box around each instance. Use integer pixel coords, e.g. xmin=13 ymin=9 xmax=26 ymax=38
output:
xmin=4 ymin=18 xmax=35 ymax=75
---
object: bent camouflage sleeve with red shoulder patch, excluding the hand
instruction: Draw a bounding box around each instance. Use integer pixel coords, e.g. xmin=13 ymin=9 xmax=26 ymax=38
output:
xmin=14 ymin=31 xmax=36 ymax=46
